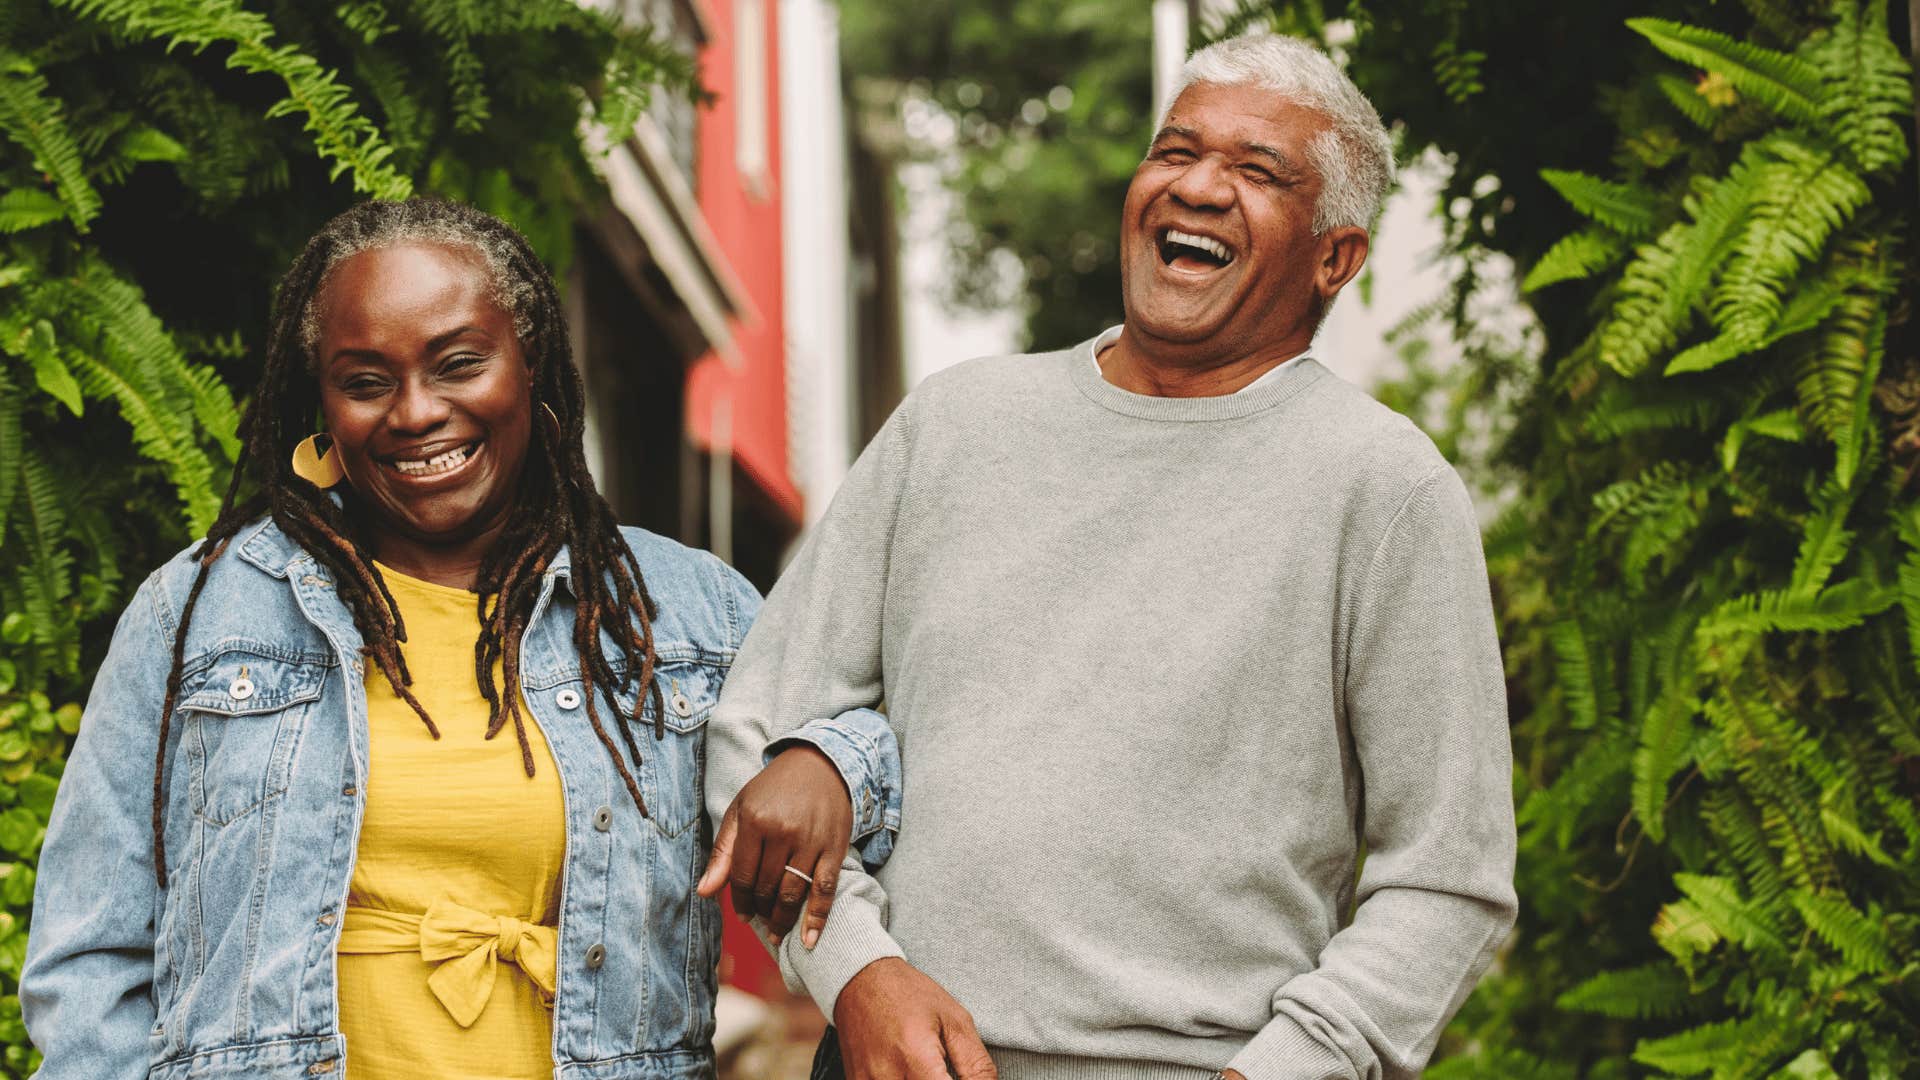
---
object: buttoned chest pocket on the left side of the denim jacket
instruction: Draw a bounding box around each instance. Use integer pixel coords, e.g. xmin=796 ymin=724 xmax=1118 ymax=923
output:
xmin=179 ymin=642 xmax=332 ymax=826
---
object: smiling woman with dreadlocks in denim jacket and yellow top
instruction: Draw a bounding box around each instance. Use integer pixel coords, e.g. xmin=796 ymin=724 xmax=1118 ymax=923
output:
xmin=21 ymin=200 xmax=899 ymax=1080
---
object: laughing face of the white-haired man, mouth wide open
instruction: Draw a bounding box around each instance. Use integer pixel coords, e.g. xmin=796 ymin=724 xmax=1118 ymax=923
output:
xmin=1119 ymin=83 xmax=1365 ymax=359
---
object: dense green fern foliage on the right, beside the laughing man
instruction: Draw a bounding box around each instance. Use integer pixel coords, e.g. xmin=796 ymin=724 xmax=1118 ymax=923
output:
xmin=1450 ymin=0 xmax=1920 ymax=1078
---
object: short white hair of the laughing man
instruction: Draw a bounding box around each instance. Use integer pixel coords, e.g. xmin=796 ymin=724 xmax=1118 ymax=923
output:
xmin=1160 ymin=33 xmax=1394 ymax=234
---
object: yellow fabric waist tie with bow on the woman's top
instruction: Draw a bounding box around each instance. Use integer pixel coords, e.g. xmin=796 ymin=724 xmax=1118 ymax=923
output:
xmin=340 ymin=897 xmax=561 ymax=1028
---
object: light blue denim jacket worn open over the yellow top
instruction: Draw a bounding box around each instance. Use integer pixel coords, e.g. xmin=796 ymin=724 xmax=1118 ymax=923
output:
xmin=21 ymin=521 xmax=900 ymax=1080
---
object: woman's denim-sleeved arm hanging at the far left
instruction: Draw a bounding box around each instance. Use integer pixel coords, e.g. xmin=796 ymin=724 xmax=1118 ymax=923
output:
xmin=19 ymin=571 xmax=173 ymax=1080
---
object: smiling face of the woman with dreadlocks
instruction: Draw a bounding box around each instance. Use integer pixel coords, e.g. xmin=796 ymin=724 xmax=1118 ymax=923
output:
xmin=315 ymin=244 xmax=532 ymax=565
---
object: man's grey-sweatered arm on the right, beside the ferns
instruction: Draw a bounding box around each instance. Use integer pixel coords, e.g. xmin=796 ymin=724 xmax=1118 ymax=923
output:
xmin=1231 ymin=465 xmax=1517 ymax=1080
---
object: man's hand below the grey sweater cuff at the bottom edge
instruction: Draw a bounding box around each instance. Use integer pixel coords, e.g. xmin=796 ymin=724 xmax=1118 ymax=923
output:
xmin=833 ymin=957 xmax=998 ymax=1080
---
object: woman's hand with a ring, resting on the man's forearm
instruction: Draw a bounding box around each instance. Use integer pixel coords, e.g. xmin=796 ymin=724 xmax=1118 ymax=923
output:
xmin=695 ymin=746 xmax=852 ymax=949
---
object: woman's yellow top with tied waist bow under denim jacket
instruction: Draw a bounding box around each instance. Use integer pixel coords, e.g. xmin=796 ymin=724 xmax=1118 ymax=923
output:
xmin=340 ymin=567 xmax=566 ymax=1080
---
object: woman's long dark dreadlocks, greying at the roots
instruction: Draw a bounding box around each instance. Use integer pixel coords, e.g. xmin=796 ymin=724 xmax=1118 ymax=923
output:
xmin=154 ymin=198 xmax=666 ymax=888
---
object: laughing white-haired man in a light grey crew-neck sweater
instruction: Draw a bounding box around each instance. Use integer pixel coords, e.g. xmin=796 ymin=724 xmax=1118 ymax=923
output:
xmin=708 ymin=37 xmax=1515 ymax=1080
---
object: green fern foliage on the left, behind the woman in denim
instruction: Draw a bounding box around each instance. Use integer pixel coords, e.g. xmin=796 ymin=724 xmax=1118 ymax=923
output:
xmin=0 ymin=0 xmax=691 ymax=1076
